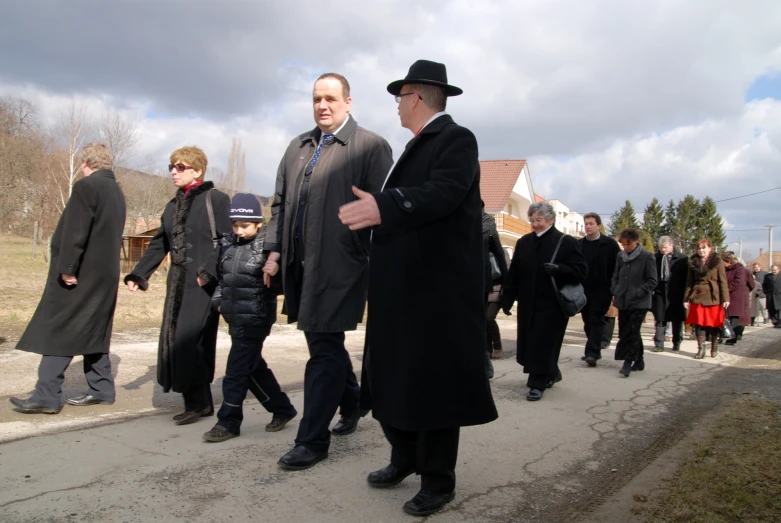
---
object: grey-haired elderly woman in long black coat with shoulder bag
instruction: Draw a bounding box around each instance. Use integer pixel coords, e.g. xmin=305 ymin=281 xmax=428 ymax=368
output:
xmin=501 ymin=202 xmax=588 ymax=401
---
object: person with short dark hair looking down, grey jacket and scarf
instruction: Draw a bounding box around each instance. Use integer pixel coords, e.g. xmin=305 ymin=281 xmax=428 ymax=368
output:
xmin=610 ymin=227 xmax=658 ymax=378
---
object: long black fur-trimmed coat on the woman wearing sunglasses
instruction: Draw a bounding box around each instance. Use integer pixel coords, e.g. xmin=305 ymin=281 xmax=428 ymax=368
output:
xmin=125 ymin=182 xmax=231 ymax=392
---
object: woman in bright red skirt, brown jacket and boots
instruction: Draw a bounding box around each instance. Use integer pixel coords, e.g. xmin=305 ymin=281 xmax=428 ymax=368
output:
xmin=683 ymin=240 xmax=729 ymax=359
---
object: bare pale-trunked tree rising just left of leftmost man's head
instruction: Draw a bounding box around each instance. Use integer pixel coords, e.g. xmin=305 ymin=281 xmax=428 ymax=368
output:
xmin=51 ymin=100 xmax=91 ymax=212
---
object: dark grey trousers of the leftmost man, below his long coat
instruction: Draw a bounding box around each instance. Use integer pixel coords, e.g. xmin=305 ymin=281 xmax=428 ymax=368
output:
xmin=30 ymin=352 xmax=116 ymax=409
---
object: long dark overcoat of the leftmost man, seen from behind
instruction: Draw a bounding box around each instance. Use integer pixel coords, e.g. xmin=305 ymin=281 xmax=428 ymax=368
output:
xmin=16 ymin=170 xmax=125 ymax=356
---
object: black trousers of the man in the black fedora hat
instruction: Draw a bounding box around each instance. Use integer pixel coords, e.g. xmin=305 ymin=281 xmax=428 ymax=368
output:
xmin=382 ymin=423 xmax=460 ymax=494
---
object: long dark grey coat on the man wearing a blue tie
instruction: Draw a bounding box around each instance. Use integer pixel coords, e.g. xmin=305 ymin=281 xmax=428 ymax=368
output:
xmin=265 ymin=116 xmax=393 ymax=332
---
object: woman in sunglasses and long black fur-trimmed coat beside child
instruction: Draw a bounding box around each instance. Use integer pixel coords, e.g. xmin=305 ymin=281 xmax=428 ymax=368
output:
xmin=125 ymin=147 xmax=231 ymax=425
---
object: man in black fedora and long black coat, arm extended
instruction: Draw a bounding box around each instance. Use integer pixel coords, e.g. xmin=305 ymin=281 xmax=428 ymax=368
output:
xmin=339 ymin=60 xmax=497 ymax=516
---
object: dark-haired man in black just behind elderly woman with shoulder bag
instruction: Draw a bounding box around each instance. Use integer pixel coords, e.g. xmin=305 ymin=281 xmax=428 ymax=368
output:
xmin=578 ymin=212 xmax=620 ymax=367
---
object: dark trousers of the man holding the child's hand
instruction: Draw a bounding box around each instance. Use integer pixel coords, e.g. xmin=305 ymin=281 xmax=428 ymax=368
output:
xmin=296 ymin=332 xmax=361 ymax=452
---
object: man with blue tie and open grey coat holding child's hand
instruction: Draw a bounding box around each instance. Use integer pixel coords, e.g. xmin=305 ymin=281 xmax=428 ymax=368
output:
xmin=264 ymin=73 xmax=393 ymax=470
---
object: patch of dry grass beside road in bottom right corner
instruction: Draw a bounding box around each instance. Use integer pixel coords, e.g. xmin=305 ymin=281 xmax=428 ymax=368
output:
xmin=633 ymin=398 xmax=781 ymax=523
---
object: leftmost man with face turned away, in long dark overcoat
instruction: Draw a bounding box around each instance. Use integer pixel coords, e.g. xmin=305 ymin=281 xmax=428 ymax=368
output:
xmin=10 ymin=143 xmax=125 ymax=414
